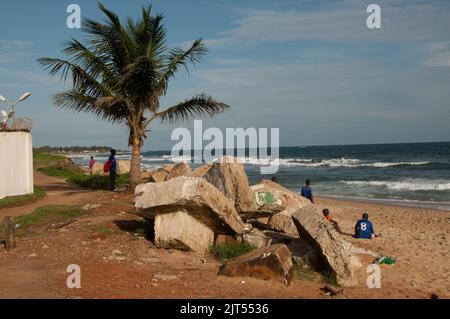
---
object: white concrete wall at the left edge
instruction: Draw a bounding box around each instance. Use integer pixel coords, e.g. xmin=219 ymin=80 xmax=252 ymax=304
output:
xmin=0 ymin=132 xmax=34 ymax=199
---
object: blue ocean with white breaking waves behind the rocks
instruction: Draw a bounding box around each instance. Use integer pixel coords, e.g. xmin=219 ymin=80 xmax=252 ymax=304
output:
xmin=69 ymin=142 xmax=450 ymax=210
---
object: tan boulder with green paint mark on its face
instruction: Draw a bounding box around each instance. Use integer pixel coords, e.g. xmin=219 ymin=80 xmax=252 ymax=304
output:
xmin=252 ymin=180 xmax=312 ymax=236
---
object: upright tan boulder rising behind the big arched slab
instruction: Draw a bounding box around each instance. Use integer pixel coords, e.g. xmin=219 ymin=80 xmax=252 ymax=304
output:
xmin=203 ymin=157 xmax=255 ymax=214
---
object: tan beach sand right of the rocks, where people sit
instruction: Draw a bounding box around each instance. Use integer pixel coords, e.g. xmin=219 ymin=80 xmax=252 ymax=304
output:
xmin=317 ymin=197 xmax=450 ymax=298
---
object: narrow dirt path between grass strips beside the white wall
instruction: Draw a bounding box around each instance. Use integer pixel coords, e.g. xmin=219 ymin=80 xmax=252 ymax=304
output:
xmin=0 ymin=172 xmax=110 ymax=220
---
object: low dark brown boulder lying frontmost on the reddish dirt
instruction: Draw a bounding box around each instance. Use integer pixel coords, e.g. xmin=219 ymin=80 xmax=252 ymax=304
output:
xmin=219 ymin=244 xmax=293 ymax=285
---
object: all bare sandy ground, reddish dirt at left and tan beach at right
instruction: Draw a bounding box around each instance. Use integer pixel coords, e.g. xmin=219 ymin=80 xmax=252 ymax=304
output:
xmin=0 ymin=174 xmax=450 ymax=298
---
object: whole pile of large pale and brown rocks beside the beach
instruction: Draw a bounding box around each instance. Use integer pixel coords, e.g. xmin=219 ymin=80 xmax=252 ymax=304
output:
xmin=135 ymin=157 xmax=358 ymax=287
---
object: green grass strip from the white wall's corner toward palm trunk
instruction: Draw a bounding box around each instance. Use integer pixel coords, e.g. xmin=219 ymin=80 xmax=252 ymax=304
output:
xmin=34 ymin=153 xmax=129 ymax=189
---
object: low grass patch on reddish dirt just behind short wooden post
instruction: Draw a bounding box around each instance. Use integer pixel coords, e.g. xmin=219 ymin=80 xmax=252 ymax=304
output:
xmin=14 ymin=205 xmax=87 ymax=233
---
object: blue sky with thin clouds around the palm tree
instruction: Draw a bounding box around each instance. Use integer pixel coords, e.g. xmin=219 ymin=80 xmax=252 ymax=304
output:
xmin=0 ymin=0 xmax=450 ymax=150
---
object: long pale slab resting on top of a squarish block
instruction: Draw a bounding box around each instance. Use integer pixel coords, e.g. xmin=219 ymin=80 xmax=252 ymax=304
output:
xmin=135 ymin=176 xmax=246 ymax=235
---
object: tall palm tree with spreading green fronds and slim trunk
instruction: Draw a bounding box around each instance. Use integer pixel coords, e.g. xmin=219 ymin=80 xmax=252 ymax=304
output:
xmin=38 ymin=3 xmax=229 ymax=188
